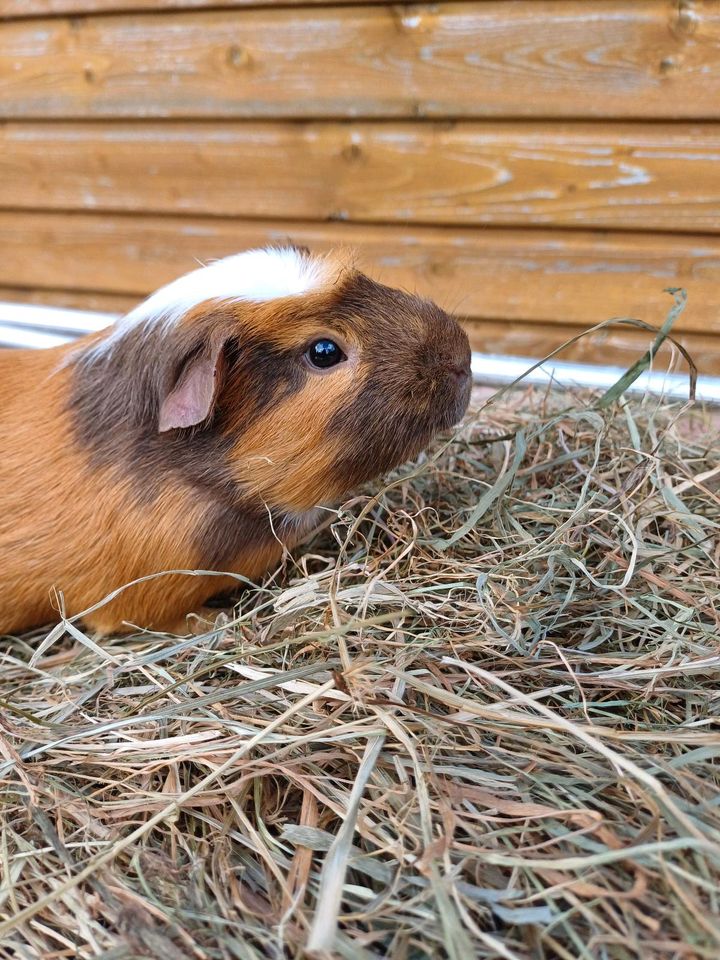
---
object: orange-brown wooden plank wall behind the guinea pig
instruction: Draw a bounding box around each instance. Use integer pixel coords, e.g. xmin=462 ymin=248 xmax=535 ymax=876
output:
xmin=0 ymin=0 xmax=720 ymax=374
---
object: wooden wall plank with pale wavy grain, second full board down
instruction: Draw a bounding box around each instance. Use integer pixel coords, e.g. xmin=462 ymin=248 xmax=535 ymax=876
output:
xmin=7 ymin=122 xmax=720 ymax=233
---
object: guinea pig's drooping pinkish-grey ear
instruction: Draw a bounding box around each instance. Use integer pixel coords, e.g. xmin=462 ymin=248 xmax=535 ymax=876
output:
xmin=158 ymin=341 xmax=225 ymax=433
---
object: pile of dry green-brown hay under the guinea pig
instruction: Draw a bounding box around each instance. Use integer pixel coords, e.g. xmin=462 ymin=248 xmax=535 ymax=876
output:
xmin=0 ymin=378 xmax=720 ymax=960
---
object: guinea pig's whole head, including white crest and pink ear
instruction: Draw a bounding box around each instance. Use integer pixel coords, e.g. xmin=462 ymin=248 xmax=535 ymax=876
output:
xmin=71 ymin=248 xmax=471 ymax=515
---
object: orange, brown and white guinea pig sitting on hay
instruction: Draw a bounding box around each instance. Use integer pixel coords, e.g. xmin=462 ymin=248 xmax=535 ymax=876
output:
xmin=0 ymin=247 xmax=470 ymax=634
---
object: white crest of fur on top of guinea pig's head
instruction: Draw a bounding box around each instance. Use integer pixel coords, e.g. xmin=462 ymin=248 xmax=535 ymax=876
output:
xmin=90 ymin=247 xmax=331 ymax=356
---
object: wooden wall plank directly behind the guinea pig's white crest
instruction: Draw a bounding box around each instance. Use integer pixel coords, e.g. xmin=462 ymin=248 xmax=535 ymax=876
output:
xmin=0 ymin=212 xmax=720 ymax=344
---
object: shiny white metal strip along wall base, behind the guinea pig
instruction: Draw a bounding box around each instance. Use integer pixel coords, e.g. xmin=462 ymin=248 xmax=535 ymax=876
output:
xmin=0 ymin=302 xmax=720 ymax=404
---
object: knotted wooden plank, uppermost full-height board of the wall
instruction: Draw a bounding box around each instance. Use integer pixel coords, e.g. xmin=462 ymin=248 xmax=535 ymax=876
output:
xmin=0 ymin=0 xmax=720 ymax=119
